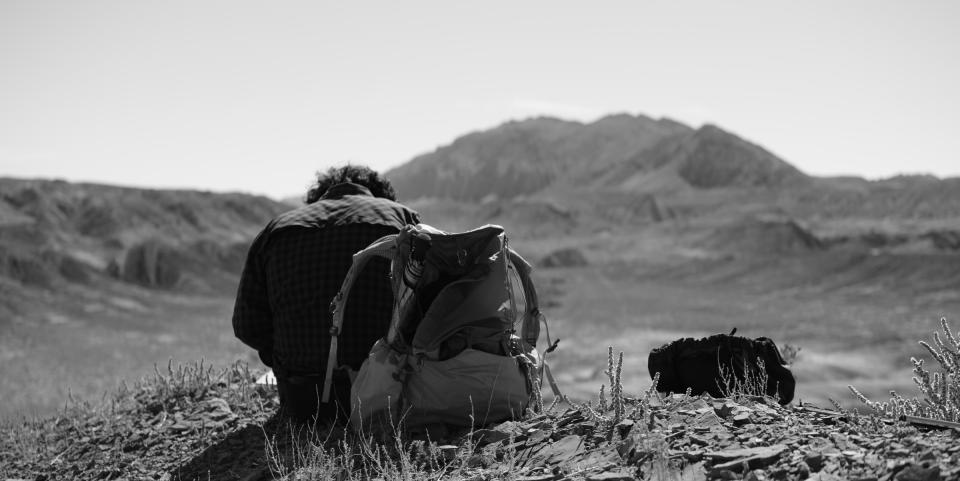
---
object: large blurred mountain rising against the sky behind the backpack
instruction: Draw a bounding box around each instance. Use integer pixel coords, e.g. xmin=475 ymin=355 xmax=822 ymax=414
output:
xmin=387 ymin=114 xmax=809 ymax=201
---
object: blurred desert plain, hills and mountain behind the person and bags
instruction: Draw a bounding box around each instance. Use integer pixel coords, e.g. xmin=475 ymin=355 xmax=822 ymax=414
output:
xmin=0 ymin=115 xmax=960 ymax=418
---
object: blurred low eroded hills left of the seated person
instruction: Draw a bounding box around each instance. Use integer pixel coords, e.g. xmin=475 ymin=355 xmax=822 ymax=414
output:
xmin=0 ymin=178 xmax=289 ymax=316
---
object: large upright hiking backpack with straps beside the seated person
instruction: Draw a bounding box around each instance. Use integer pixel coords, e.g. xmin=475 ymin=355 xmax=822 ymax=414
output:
xmin=322 ymin=224 xmax=555 ymax=429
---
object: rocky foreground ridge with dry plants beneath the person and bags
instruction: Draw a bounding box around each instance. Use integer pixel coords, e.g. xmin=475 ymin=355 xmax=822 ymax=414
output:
xmin=0 ymin=364 xmax=960 ymax=481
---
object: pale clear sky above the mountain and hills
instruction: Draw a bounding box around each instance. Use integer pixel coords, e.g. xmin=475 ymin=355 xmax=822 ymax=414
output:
xmin=0 ymin=0 xmax=960 ymax=197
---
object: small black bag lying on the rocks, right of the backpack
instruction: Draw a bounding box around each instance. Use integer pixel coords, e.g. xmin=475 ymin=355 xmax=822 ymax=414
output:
xmin=647 ymin=329 xmax=796 ymax=404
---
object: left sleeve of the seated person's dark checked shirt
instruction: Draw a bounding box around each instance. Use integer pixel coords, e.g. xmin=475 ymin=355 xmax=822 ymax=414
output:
xmin=233 ymin=230 xmax=273 ymax=354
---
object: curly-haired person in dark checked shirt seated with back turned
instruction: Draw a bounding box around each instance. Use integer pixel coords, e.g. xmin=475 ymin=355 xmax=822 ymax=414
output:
xmin=233 ymin=165 xmax=420 ymax=421
